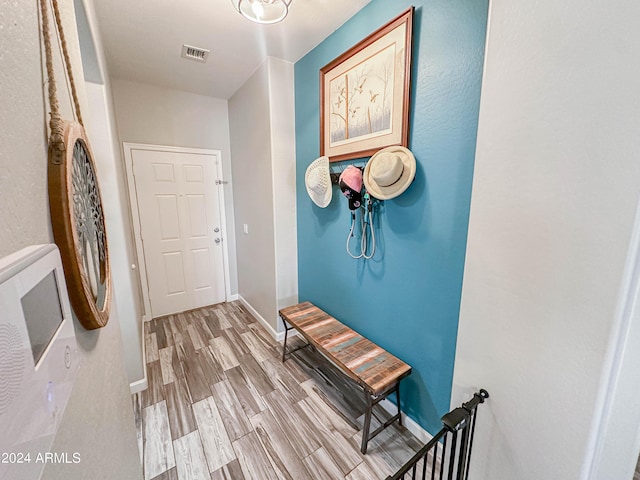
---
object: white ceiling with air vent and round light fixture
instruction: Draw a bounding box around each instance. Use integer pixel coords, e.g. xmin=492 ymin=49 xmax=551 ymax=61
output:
xmin=94 ymin=0 xmax=371 ymax=99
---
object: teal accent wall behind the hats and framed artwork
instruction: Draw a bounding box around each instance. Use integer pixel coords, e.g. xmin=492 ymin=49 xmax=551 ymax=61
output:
xmin=295 ymin=0 xmax=488 ymax=433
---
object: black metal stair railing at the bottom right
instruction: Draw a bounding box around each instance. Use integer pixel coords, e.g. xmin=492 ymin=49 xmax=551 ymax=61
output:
xmin=386 ymin=389 xmax=489 ymax=480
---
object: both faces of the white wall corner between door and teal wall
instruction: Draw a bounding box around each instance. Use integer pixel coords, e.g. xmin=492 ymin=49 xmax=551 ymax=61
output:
xmin=229 ymin=57 xmax=298 ymax=335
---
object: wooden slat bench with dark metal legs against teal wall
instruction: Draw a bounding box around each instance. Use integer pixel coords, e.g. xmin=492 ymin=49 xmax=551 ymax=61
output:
xmin=280 ymin=302 xmax=411 ymax=453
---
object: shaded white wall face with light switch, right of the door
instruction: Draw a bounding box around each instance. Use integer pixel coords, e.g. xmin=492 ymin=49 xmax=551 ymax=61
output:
xmin=229 ymin=62 xmax=278 ymax=330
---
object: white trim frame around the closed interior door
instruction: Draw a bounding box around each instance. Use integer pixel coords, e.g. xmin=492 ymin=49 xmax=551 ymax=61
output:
xmin=122 ymin=142 xmax=231 ymax=320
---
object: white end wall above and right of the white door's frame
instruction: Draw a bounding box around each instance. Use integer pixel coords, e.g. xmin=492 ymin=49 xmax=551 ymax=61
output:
xmin=112 ymin=78 xmax=238 ymax=295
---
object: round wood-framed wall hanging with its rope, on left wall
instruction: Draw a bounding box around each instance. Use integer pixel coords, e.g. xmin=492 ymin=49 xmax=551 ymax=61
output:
xmin=40 ymin=0 xmax=111 ymax=329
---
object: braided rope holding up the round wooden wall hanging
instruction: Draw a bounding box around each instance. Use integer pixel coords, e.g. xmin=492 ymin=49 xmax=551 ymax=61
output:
xmin=40 ymin=0 xmax=83 ymax=163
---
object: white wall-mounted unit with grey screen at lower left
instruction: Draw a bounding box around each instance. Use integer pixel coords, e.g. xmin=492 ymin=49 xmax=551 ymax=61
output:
xmin=0 ymin=244 xmax=80 ymax=480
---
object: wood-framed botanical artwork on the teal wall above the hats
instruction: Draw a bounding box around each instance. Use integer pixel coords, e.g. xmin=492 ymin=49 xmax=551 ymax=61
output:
xmin=320 ymin=7 xmax=413 ymax=162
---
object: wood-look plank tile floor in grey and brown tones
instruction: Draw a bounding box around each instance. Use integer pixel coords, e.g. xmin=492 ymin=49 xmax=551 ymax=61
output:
xmin=133 ymin=302 xmax=421 ymax=480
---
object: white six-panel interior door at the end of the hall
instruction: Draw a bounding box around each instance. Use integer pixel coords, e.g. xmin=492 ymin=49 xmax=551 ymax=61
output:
xmin=131 ymin=150 xmax=225 ymax=318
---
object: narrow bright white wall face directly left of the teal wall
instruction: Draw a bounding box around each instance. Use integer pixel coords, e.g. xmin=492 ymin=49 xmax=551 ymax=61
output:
xmin=267 ymin=57 xmax=298 ymax=316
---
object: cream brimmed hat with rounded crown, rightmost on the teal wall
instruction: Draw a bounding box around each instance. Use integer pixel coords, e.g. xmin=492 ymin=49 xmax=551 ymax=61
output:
xmin=362 ymin=146 xmax=416 ymax=200
